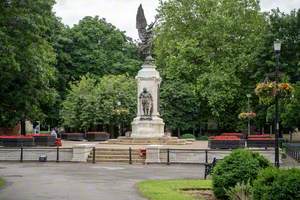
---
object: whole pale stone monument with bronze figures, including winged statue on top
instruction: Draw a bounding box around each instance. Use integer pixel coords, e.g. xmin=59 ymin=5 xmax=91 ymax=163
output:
xmin=131 ymin=5 xmax=165 ymax=138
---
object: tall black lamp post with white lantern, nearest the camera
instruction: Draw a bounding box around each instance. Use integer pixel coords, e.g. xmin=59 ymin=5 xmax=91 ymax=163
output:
xmin=274 ymin=40 xmax=281 ymax=168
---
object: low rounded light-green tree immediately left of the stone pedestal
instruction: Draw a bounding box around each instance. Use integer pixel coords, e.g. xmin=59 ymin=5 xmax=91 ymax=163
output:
xmin=61 ymin=75 xmax=136 ymax=136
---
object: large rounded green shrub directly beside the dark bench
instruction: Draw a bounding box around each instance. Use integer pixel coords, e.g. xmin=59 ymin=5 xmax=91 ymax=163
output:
xmin=212 ymin=150 xmax=271 ymax=199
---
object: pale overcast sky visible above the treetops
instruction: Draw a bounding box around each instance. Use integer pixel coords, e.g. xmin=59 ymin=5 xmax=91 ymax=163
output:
xmin=54 ymin=0 xmax=300 ymax=39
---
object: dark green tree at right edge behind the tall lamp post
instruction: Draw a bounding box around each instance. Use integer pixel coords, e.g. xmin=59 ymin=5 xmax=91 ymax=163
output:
xmin=253 ymin=9 xmax=300 ymax=128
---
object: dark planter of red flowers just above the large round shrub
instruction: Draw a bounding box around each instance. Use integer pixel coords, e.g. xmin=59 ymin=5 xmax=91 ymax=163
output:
xmin=208 ymin=135 xmax=245 ymax=149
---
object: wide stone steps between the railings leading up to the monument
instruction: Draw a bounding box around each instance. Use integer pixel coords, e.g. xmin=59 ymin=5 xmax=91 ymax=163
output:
xmin=88 ymin=148 xmax=145 ymax=164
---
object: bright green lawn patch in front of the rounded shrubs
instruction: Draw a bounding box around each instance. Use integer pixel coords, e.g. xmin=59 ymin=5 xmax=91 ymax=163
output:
xmin=138 ymin=180 xmax=212 ymax=200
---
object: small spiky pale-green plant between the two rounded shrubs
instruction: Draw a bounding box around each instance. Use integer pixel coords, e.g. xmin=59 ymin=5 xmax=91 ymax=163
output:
xmin=226 ymin=181 xmax=252 ymax=200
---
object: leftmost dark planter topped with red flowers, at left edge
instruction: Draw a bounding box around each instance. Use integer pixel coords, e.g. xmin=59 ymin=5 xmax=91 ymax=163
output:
xmin=0 ymin=135 xmax=34 ymax=147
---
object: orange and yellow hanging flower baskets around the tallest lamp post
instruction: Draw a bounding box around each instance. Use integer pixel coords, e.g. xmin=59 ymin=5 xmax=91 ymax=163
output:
xmin=255 ymin=82 xmax=294 ymax=104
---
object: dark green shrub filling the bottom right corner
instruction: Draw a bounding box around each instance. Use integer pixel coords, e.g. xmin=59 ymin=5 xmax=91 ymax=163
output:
xmin=253 ymin=167 xmax=300 ymax=200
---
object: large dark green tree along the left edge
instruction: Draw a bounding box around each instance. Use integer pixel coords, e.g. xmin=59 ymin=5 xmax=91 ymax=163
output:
xmin=0 ymin=0 xmax=57 ymax=133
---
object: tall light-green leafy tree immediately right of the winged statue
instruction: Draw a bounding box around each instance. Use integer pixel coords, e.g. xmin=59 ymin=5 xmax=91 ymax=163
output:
xmin=154 ymin=0 xmax=266 ymax=132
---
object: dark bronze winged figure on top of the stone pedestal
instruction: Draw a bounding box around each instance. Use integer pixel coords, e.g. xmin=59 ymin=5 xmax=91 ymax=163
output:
xmin=136 ymin=4 xmax=157 ymax=58
